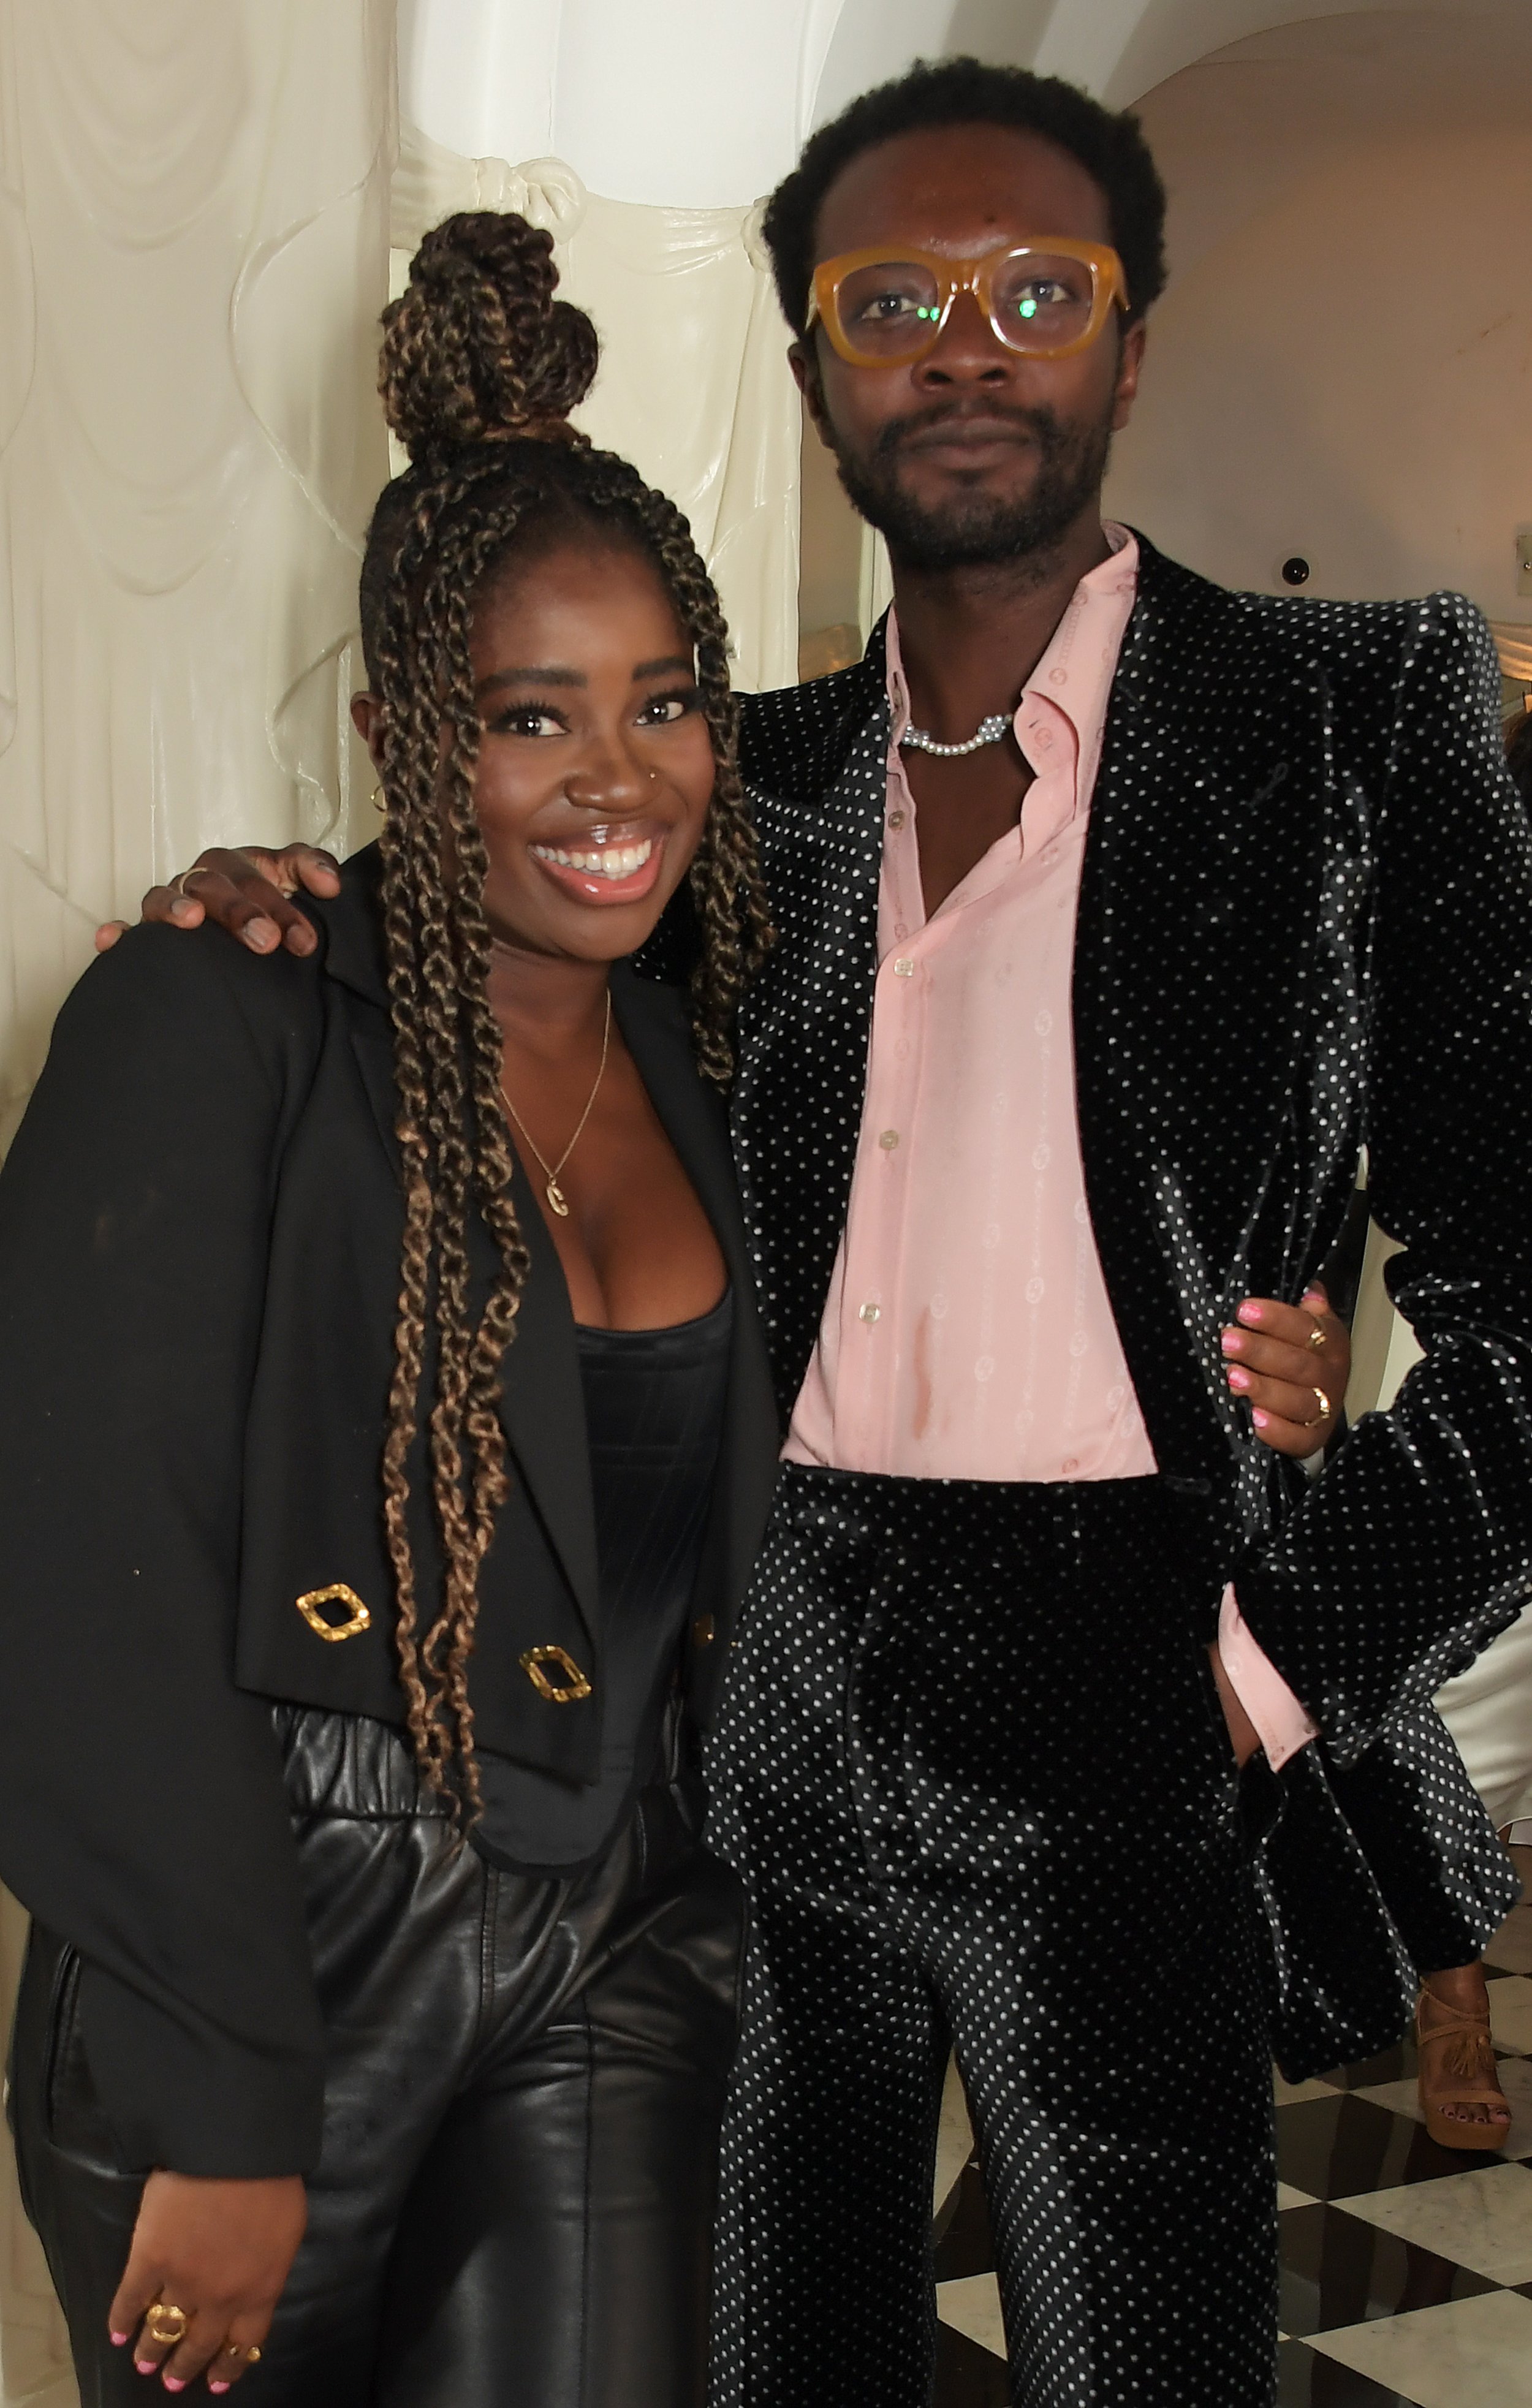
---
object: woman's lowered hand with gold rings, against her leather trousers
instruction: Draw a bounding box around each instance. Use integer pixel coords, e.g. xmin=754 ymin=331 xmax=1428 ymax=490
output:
xmin=111 ymin=2175 xmax=308 ymax=2391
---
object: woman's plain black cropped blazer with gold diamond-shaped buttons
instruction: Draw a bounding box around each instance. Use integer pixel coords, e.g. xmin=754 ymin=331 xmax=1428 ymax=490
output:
xmin=0 ymin=850 xmax=778 ymax=2175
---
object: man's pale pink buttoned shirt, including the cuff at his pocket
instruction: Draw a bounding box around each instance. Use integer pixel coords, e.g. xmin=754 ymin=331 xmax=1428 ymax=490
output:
xmin=785 ymin=528 xmax=1313 ymax=1765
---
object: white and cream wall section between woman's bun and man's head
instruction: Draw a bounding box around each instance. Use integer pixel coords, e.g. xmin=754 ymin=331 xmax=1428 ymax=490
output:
xmin=395 ymin=0 xmax=862 ymax=689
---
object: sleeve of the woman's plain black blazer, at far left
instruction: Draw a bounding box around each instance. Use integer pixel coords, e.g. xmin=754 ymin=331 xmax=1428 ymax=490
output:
xmin=0 ymin=927 xmax=323 ymax=2175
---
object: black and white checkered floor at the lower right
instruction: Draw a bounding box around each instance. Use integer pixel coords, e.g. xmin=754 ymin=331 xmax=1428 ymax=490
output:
xmin=937 ymin=1849 xmax=1532 ymax=2408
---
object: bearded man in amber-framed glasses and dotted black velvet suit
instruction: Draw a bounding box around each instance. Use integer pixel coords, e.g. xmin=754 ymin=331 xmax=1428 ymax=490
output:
xmin=119 ymin=60 xmax=1532 ymax=2408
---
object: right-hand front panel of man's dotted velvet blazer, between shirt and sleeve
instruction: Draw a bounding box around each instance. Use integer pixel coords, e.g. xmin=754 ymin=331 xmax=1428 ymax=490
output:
xmin=1074 ymin=544 xmax=1330 ymax=1486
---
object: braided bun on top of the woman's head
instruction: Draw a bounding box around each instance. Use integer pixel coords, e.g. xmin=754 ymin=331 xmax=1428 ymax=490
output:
xmin=378 ymin=210 xmax=600 ymax=460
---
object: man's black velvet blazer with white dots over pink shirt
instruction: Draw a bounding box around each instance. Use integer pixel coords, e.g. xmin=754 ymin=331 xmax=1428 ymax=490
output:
xmin=732 ymin=537 xmax=1532 ymax=1763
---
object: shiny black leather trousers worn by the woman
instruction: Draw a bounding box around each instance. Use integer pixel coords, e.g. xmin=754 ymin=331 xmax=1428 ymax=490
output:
xmin=12 ymin=1709 xmax=742 ymax=2408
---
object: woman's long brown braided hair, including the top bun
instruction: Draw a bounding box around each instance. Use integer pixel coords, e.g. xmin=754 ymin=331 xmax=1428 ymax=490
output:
xmin=362 ymin=210 xmax=771 ymax=1823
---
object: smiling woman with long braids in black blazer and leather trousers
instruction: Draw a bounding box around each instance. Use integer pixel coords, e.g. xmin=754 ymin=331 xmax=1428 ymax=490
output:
xmin=0 ymin=214 xmax=778 ymax=2408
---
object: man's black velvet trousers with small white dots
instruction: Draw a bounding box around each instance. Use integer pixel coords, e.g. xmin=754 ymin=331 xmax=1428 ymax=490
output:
xmin=711 ymin=1464 xmax=1276 ymax=2408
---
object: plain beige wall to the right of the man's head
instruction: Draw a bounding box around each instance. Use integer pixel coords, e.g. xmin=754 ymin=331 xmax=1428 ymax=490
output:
xmin=1108 ymin=7 xmax=1532 ymax=621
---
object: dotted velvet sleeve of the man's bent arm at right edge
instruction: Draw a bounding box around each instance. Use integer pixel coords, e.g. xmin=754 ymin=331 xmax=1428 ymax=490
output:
xmin=1238 ymin=595 xmax=1532 ymax=1763
